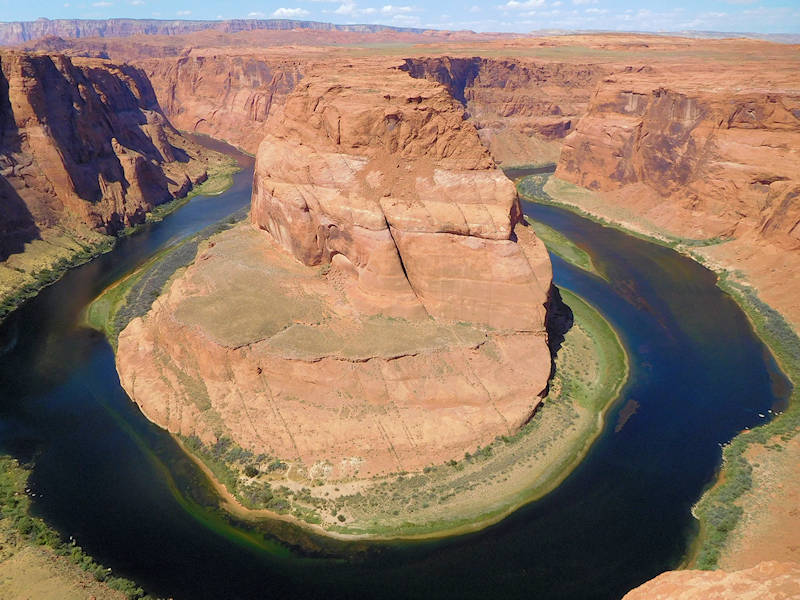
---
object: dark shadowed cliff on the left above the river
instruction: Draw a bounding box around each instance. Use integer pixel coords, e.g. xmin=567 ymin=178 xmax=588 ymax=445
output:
xmin=0 ymin=52 xmax=223 ymax=260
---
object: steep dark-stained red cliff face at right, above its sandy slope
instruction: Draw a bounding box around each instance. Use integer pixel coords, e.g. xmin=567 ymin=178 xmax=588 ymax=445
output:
xmin=556 ymin=77 xmax=800 ymax=247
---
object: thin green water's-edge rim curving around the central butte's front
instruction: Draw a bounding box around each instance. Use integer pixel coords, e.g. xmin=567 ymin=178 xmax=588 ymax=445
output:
xmin=164 ymin=289 xmax=630 ymax=542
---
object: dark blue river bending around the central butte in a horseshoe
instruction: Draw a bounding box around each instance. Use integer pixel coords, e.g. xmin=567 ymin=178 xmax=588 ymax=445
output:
xmin=0 ymin=146 xmax=786 ymax=600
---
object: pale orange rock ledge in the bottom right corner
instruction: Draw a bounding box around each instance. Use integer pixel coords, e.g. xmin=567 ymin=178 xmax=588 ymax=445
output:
xmin=623 ymin=561 xmax=800 ymax=600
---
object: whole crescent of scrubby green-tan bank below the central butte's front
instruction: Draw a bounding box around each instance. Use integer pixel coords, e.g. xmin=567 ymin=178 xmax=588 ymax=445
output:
xmin=177 ymin=291 xmax=628 ymax=537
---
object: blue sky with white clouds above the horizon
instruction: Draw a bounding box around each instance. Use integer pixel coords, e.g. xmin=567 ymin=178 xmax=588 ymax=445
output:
xmin=0 ymin=0 xmax=800 ymax=33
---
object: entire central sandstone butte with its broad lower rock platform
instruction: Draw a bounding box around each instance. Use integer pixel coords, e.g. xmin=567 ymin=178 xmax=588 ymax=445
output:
xmin=117 ymin=61 xmax=551 ymax=477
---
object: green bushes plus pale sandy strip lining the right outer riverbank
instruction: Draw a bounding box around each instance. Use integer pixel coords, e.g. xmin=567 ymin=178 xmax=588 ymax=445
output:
xmin=516 ymin=174 xmax=800 ymax=569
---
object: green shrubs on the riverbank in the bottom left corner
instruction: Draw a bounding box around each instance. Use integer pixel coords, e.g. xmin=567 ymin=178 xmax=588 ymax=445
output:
xmin=0 ymin=455 xmax=158 ymax=600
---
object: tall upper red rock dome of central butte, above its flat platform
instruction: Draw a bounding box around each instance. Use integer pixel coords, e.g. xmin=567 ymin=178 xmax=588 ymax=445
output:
xmin=252 ymin=59 xmax=551 ymax=331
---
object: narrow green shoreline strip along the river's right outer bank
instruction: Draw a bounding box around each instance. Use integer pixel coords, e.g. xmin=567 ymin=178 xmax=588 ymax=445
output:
xmin=517 ymin=175 xmax=800 ymax=569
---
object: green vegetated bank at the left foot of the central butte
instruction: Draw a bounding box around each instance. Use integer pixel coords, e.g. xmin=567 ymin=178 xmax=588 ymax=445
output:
xmin=86 ymin=209 xmax=247 ymax=347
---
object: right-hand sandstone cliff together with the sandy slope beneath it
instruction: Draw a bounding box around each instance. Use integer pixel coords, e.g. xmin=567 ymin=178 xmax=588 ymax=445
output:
xmin=556 ymin=63 xmax=800 ymax=325
